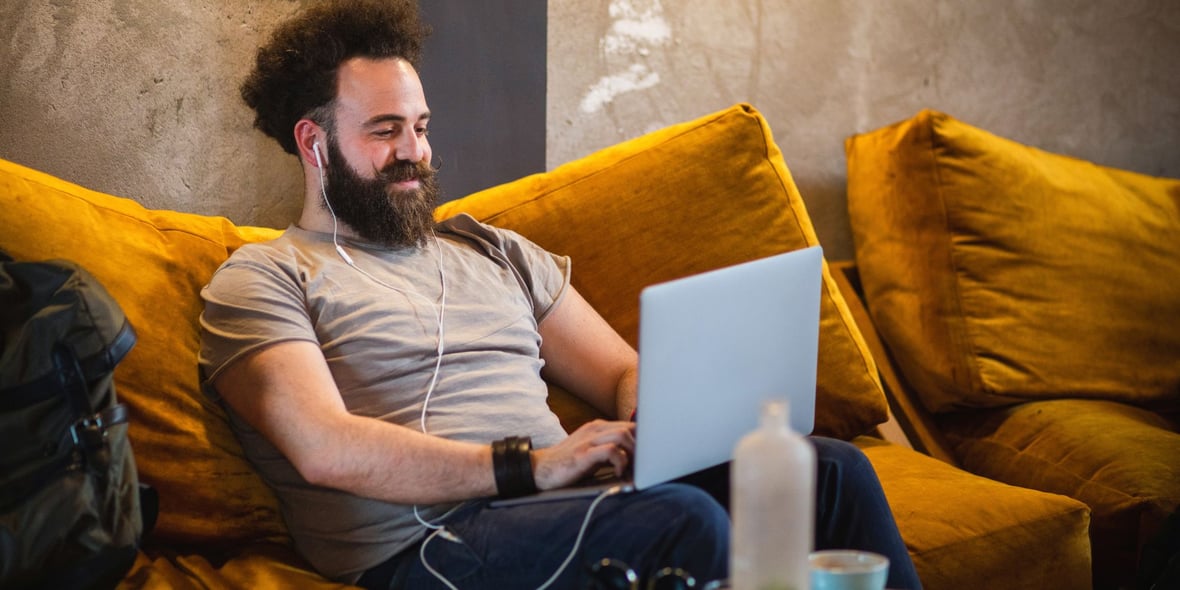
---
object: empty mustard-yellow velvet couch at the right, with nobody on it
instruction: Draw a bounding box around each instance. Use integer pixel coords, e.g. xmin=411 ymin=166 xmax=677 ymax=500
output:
xmin=843 ymin=110 xmax=1180 ymax=588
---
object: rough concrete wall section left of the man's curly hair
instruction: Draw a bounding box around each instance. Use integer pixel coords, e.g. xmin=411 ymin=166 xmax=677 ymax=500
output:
xmin=0 ymin=0 xmax=303 ymax=227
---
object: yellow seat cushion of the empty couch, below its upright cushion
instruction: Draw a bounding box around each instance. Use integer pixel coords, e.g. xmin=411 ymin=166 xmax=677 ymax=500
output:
xmin=943 ymin=400 xmax=1180 ymax=588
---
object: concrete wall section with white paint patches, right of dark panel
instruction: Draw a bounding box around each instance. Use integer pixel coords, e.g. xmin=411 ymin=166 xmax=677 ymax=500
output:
xmin=546 ymin=0 xmax=1180 ymax=258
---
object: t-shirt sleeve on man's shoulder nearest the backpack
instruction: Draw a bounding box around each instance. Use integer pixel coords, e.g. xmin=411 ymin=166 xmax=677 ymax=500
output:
xmin=198 ymin=253 xmax=316 ymax=398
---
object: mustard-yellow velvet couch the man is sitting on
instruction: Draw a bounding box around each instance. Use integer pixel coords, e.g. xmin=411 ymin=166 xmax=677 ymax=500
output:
xmin=0 ymin=105 xmax=1090 ymax=590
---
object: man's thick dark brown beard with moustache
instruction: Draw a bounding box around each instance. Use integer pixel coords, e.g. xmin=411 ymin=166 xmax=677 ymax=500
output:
xmin=325 ymin=139 xmax=439 ymax=248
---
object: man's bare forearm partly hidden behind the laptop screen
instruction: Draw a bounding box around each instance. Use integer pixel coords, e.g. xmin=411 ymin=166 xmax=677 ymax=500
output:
xmin=539 ymin=286 xmax=640 ymax=420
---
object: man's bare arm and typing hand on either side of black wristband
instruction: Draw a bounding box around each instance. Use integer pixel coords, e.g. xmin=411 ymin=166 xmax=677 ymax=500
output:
xmin=215 ymin=341 xmax=634 ymax=504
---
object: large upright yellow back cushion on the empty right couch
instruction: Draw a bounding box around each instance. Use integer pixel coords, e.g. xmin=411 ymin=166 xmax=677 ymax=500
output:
xmin=846 ymin=111 xmax=1180 ymax=412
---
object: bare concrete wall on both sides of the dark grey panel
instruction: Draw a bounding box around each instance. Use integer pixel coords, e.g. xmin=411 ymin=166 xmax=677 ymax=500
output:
xmin=0 ymin=0 xmax=1180 ymax=258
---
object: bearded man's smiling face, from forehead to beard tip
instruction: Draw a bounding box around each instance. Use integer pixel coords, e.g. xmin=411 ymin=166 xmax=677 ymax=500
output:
xmin=325 ymin=58 xmax=439 ymax=247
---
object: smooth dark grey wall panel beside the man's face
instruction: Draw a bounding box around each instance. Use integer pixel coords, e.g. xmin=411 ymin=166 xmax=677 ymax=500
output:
xmin=420 ymin=0 xmax=548 ymax=201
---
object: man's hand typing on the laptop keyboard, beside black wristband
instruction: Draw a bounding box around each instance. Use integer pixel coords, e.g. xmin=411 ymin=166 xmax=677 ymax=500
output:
xmin=532 ymin=420 xmax=635 ymax=490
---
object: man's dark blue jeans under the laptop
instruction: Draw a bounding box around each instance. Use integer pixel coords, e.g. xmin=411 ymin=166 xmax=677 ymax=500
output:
xmin=360 ymin=437 xmax=920 ymax=590
